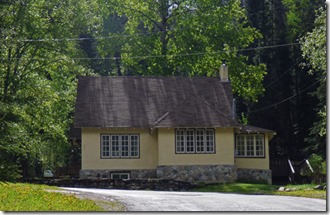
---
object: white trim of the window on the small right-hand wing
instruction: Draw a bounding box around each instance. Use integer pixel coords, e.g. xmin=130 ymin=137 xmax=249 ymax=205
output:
xmin=235 ymin=134 xmax=266 ymax=158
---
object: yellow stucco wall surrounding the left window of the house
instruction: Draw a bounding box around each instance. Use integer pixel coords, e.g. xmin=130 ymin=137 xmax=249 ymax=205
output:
xmin=81 ymin=128 xmax=158 ymax=170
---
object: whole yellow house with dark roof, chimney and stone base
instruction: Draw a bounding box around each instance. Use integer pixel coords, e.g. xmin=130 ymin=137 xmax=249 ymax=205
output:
xmin=74 ymin=65 xmax=275 ymax=183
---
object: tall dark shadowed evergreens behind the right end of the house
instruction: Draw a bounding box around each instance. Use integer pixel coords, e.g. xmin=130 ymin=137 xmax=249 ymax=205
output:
xmin=245 ymin=0 xmax=324 ymax=160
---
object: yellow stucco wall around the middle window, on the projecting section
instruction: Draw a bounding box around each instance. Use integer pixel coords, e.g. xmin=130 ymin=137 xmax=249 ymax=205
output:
xmin=158 ymin=128 xmax=235 ymax=165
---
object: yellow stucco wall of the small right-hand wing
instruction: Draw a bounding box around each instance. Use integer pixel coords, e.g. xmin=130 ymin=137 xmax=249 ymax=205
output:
xmin=236 ymin=134 xmax=271 ymax=169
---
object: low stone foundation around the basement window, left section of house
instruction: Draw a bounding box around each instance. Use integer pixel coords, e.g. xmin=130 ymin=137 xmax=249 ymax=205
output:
xmin=79 ymin=169 xmax=156 ymax=179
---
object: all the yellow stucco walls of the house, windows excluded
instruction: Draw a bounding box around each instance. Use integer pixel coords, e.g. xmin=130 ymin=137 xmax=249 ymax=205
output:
xmin=81 ymin=128 xmax=269 ymax=170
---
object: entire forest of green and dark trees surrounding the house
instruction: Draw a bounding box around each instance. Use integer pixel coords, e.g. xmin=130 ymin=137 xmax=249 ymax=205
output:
xmin=0 ymin=0 xmax=327 ymax=180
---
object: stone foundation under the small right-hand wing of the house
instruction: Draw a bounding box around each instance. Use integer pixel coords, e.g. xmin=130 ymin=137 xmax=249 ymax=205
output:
xmin=237 ymin=169 xmax=272 ymax=184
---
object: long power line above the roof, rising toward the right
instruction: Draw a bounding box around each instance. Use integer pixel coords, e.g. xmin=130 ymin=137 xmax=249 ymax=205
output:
xmin=0 ymin=43 xmax=300 ymax=60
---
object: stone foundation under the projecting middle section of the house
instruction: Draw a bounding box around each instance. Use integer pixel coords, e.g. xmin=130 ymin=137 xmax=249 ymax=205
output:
xmin=157 ymin=165 xmax=237 ymax=183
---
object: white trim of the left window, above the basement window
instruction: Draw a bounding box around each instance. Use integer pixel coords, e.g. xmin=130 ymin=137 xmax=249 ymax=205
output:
xmin=100 ymin=134 xmax=140 ymax=159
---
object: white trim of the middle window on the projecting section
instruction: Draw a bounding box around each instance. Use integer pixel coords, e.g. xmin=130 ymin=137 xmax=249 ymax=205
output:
xmin=175 ymin=128 xmax=215 ymax=154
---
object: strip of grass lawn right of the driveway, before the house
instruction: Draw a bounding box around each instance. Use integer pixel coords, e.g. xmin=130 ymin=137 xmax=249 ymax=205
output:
xmin=194 ymin=183 xmax=326 ymax=199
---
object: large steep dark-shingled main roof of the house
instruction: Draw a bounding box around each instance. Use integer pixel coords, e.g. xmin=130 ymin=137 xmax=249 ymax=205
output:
xmin=74 ymin=77 xmax=239 ymax=128
